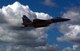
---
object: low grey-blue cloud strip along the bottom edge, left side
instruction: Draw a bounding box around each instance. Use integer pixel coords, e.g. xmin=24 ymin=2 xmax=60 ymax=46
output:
xmin=0 ymin=44 xmax=59 ymax=51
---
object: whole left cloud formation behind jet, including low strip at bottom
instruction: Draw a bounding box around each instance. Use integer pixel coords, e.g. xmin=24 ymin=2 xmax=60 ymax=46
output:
xmin=0 ymin=2 xmax=57 ymax=51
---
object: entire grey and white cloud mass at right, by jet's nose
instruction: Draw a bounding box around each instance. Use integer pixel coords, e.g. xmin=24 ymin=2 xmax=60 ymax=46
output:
xmin=57 ymin=8 xmax=80 ymax=44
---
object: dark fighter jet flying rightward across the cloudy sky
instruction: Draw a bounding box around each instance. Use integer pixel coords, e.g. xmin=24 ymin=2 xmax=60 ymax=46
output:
xmin=22 ymin=15 xmax=70 ymax=28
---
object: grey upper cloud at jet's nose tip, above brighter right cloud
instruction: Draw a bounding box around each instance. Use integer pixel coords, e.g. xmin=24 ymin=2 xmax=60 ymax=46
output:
xmin=63 ymin=8 xmax=80 ymax=25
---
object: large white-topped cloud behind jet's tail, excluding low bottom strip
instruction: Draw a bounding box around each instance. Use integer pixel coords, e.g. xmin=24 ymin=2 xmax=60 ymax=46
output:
xmin=0 ymin=2 xmax=51 ymax=46
